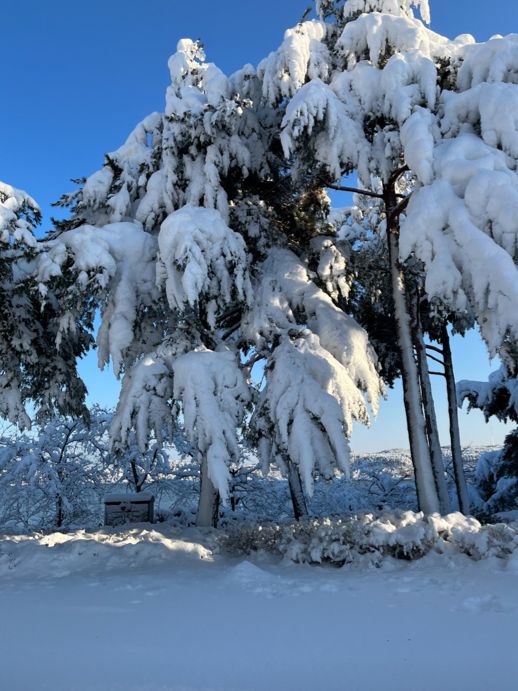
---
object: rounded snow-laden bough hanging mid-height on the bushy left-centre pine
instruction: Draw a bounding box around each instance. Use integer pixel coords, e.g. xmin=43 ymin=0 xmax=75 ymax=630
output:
xmin=157 ymin=206 xmax=251 ymax=326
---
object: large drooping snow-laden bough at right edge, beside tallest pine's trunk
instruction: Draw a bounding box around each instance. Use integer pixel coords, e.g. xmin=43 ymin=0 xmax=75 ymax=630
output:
xmin=400 ymin=133 xmax=518 ymax=362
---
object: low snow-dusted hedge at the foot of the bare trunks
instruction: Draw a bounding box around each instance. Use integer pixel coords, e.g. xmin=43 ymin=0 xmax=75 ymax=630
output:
xmin=223 ymin=511 xmax=518 ymax=566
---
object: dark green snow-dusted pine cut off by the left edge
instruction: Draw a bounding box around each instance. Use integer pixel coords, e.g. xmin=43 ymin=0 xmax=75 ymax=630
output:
xmin=0 ymin=178 xmax=90 ymax=429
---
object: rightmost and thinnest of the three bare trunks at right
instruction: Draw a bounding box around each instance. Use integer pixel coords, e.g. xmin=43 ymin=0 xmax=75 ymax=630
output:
xmin=441 ymin=324 xmax=470 ymax=515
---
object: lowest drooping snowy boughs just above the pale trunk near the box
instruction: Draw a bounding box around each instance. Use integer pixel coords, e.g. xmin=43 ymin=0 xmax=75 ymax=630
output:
xmin=111 ymin=348 xmax=250 ymax=501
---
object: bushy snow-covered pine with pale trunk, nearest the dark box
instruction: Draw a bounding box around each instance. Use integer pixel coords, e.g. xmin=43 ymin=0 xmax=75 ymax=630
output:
xmin=42 ymin=40 xmax=262 ymax=523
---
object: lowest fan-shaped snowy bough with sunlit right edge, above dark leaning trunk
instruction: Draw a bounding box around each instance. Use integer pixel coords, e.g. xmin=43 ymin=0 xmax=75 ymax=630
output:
xmin=252 ymin=331 xmax=368 ymax=495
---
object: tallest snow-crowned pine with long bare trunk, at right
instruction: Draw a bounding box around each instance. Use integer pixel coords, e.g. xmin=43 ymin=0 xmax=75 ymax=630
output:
xmin=259 ymin=0 xmax=518 ymax=512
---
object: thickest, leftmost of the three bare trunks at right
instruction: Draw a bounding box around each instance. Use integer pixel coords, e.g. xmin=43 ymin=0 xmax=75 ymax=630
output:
xmin=384 ymin=185 xmax=440 ymax=514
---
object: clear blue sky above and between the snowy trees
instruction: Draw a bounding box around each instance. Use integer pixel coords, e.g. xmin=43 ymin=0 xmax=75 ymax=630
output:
xmin=0 ymin=0 xmax=518 ymax=451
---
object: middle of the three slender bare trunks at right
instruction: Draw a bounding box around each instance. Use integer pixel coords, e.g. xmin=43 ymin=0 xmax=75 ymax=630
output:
xmin=414 ymin=316 xmax=451 ymax=514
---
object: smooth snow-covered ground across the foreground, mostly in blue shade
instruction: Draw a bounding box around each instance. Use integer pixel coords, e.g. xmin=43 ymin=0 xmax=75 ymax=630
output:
xmin=0 ymin=526 xmax=518 ymax=691
